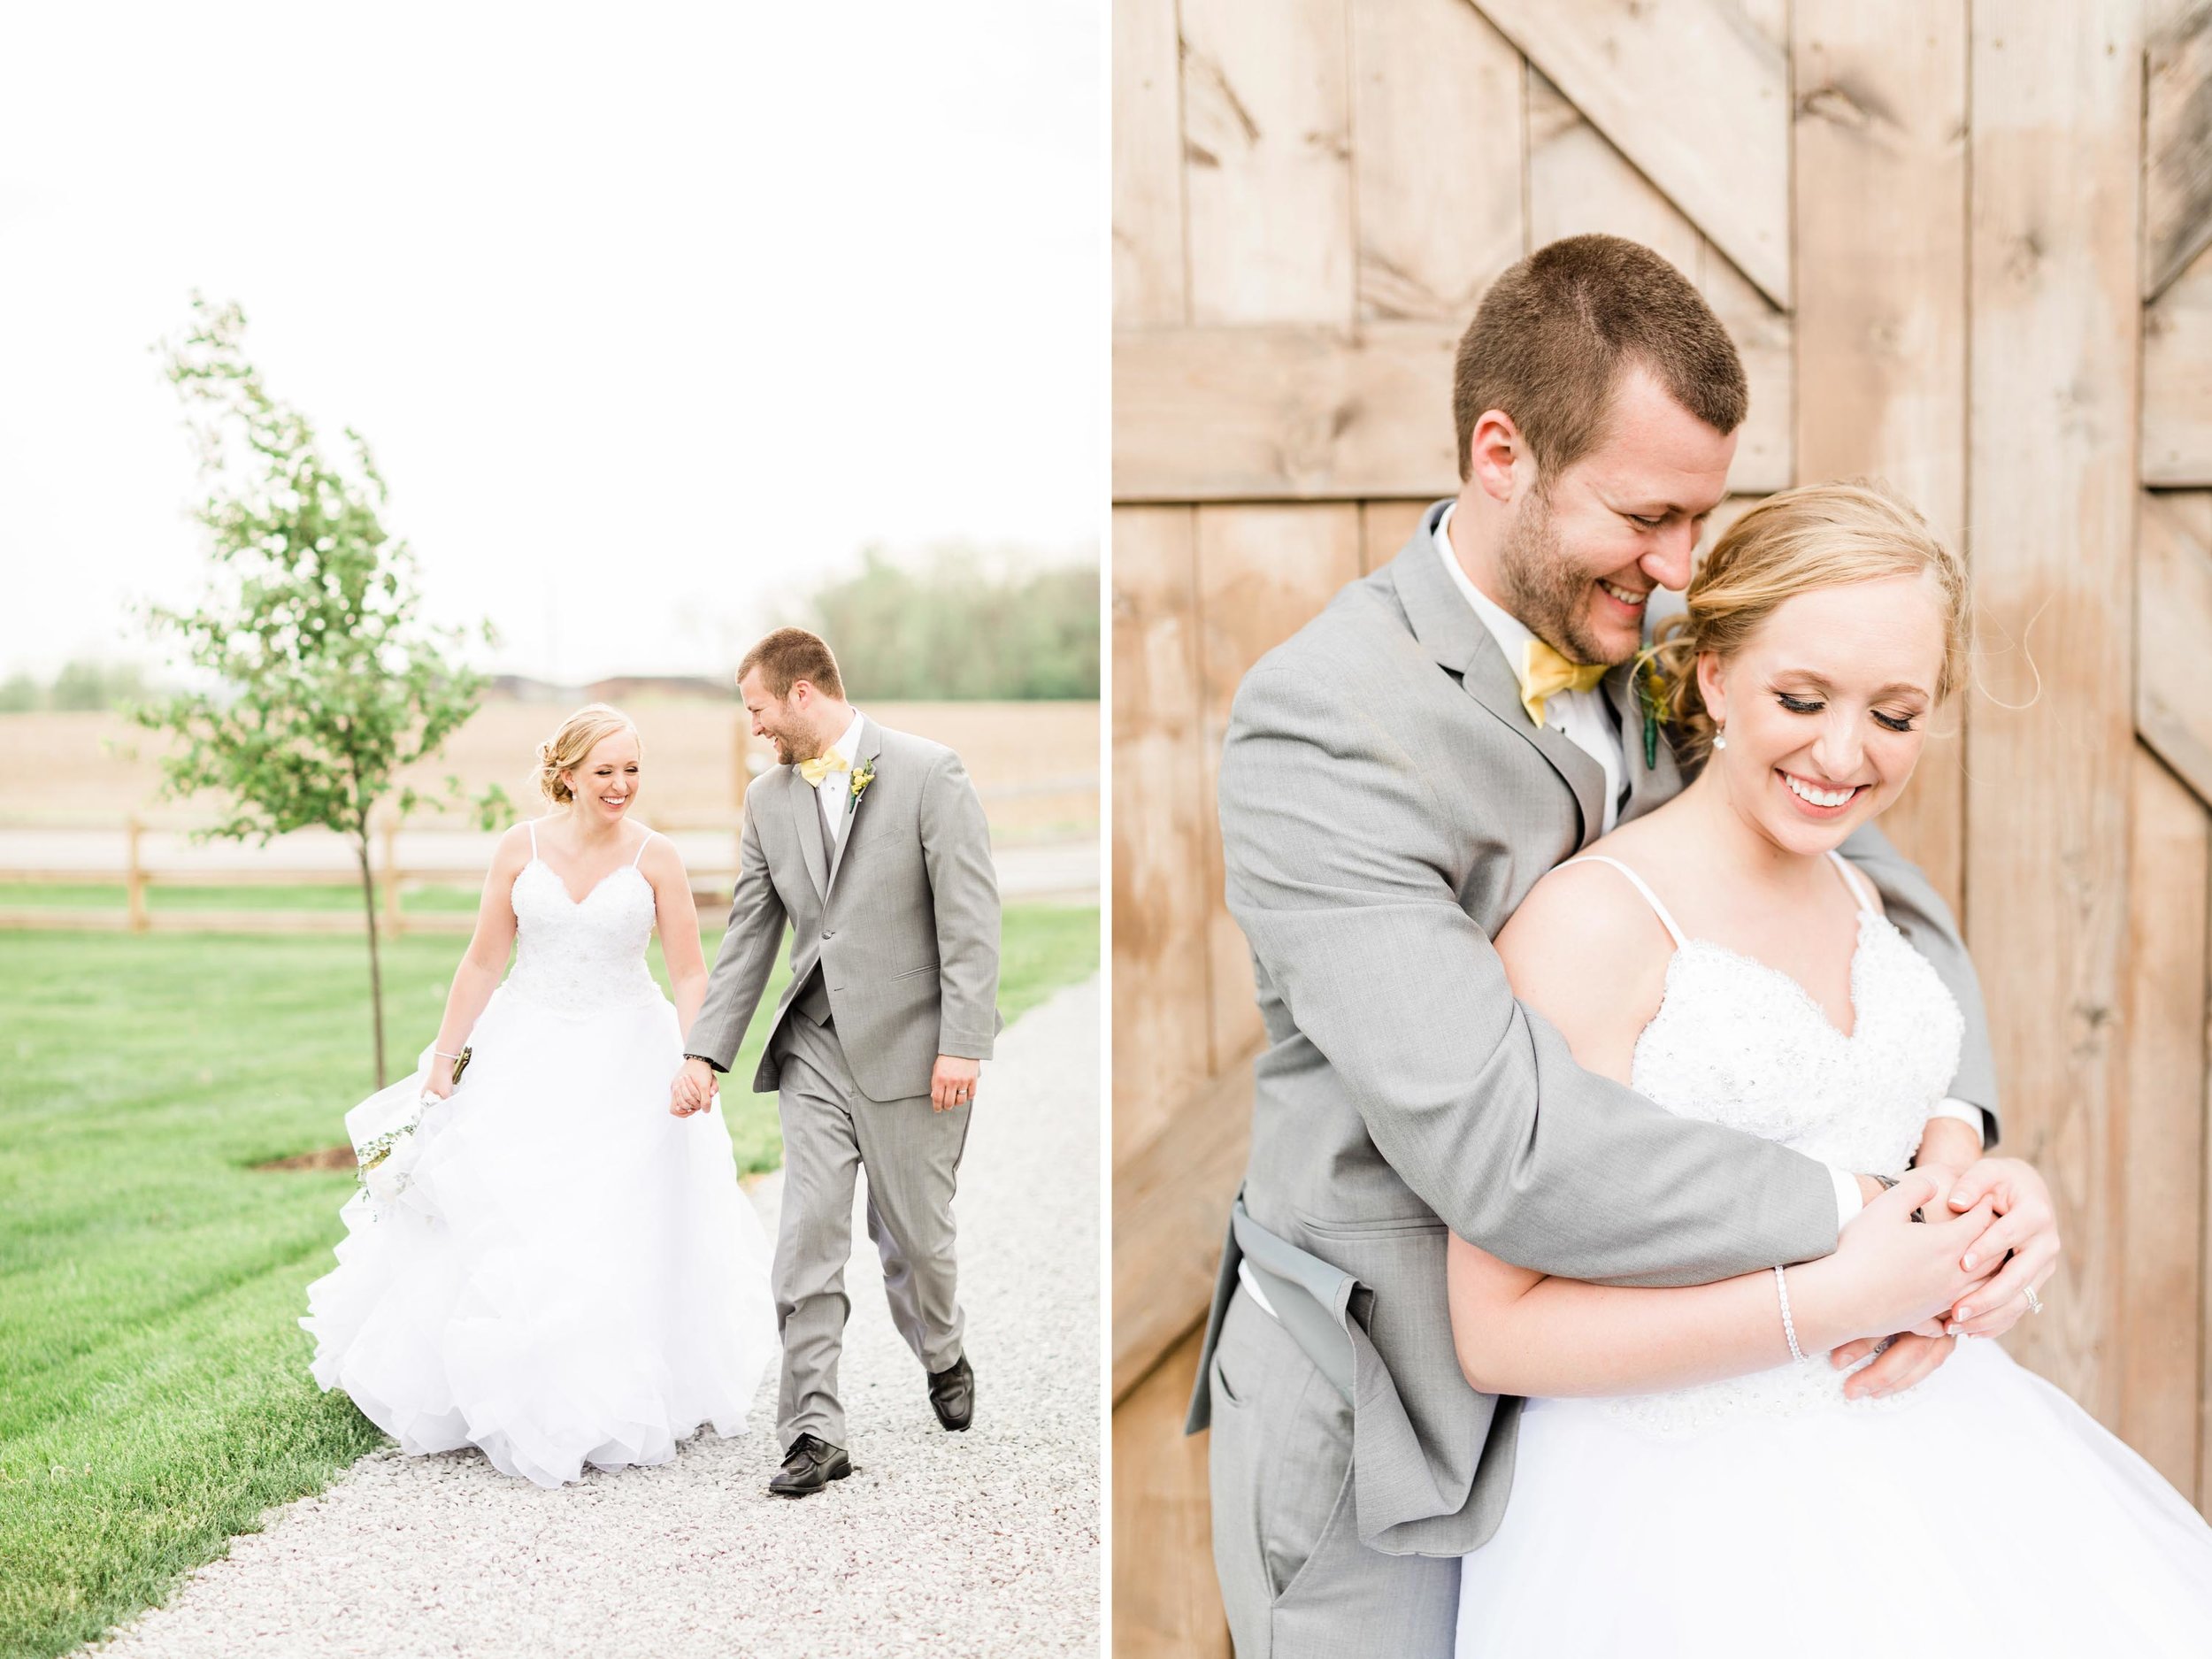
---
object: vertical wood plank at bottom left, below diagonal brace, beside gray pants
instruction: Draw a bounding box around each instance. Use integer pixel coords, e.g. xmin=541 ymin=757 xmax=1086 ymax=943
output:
xmin=1113 ymin=1336 xmax=1230 ymax=1659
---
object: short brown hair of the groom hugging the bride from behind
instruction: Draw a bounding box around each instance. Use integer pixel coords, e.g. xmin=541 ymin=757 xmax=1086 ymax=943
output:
xmin=1451 ymin=234 xmax=1750 ymax=485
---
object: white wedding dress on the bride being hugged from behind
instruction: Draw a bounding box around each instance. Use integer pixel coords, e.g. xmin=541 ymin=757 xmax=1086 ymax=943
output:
xmin=1458 ymin=861 xmax=2212 ymax=1659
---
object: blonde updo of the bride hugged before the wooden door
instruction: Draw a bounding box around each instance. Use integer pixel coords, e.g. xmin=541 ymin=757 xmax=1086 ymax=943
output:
xmin=1653 ymin=480 xmax=1971 ymax=759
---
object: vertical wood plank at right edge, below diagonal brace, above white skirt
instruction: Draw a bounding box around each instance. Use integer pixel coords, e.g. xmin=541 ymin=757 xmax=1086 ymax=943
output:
xmin=2117 ymin=748 xmax=2212 ymax=1494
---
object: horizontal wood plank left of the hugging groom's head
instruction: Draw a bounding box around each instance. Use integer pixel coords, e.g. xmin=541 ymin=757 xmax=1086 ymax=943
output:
xmin=1113 ymin=323 xmax=1460 ymax=503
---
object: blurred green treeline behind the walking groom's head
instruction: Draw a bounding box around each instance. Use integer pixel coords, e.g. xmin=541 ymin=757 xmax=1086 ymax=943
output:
xmin=814 ymin=551 xmax=1100 ymax=703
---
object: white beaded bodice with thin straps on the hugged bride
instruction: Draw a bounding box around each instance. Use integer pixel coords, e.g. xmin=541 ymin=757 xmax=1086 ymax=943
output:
xmin=1566 ymin=861 xmax=1967 ymax=1433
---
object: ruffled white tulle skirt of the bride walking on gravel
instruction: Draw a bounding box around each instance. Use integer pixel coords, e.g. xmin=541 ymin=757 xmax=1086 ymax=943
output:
xmin=301 ymin=987 xmax=777 ymax=1486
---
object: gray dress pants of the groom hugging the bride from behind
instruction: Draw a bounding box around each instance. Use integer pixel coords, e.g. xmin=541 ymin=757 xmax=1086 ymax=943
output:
xmin=1208 ymin=1287 xmax=1460 ymax=1659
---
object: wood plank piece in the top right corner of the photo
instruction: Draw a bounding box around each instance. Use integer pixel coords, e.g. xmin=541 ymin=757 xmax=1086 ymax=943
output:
xmin=2144 ymin=0 xmax=2212 ymax=299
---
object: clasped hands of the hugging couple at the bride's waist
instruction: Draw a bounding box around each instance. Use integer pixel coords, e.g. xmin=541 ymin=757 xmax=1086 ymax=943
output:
xmin=1830 ymin=1148 xmax=2060 ymax=1401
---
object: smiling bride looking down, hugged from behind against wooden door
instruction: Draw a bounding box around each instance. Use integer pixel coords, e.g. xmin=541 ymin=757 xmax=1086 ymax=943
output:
xmin=1449 ymin=485 xmax=2212 ymax=1659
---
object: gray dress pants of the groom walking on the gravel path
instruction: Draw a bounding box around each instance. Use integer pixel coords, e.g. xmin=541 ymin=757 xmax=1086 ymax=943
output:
xmin=770 ymin=1011 xmax=976 ymax=1451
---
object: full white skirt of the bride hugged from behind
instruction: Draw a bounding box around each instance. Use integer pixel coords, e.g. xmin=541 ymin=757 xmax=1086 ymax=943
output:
xmin=1458 ymin=1343 xmax=2212 ymax=1659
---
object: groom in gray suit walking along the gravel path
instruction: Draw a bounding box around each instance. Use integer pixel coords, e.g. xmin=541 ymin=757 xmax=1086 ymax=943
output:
xmin=671 ymin=628 xmax=1002 ymax=1498
